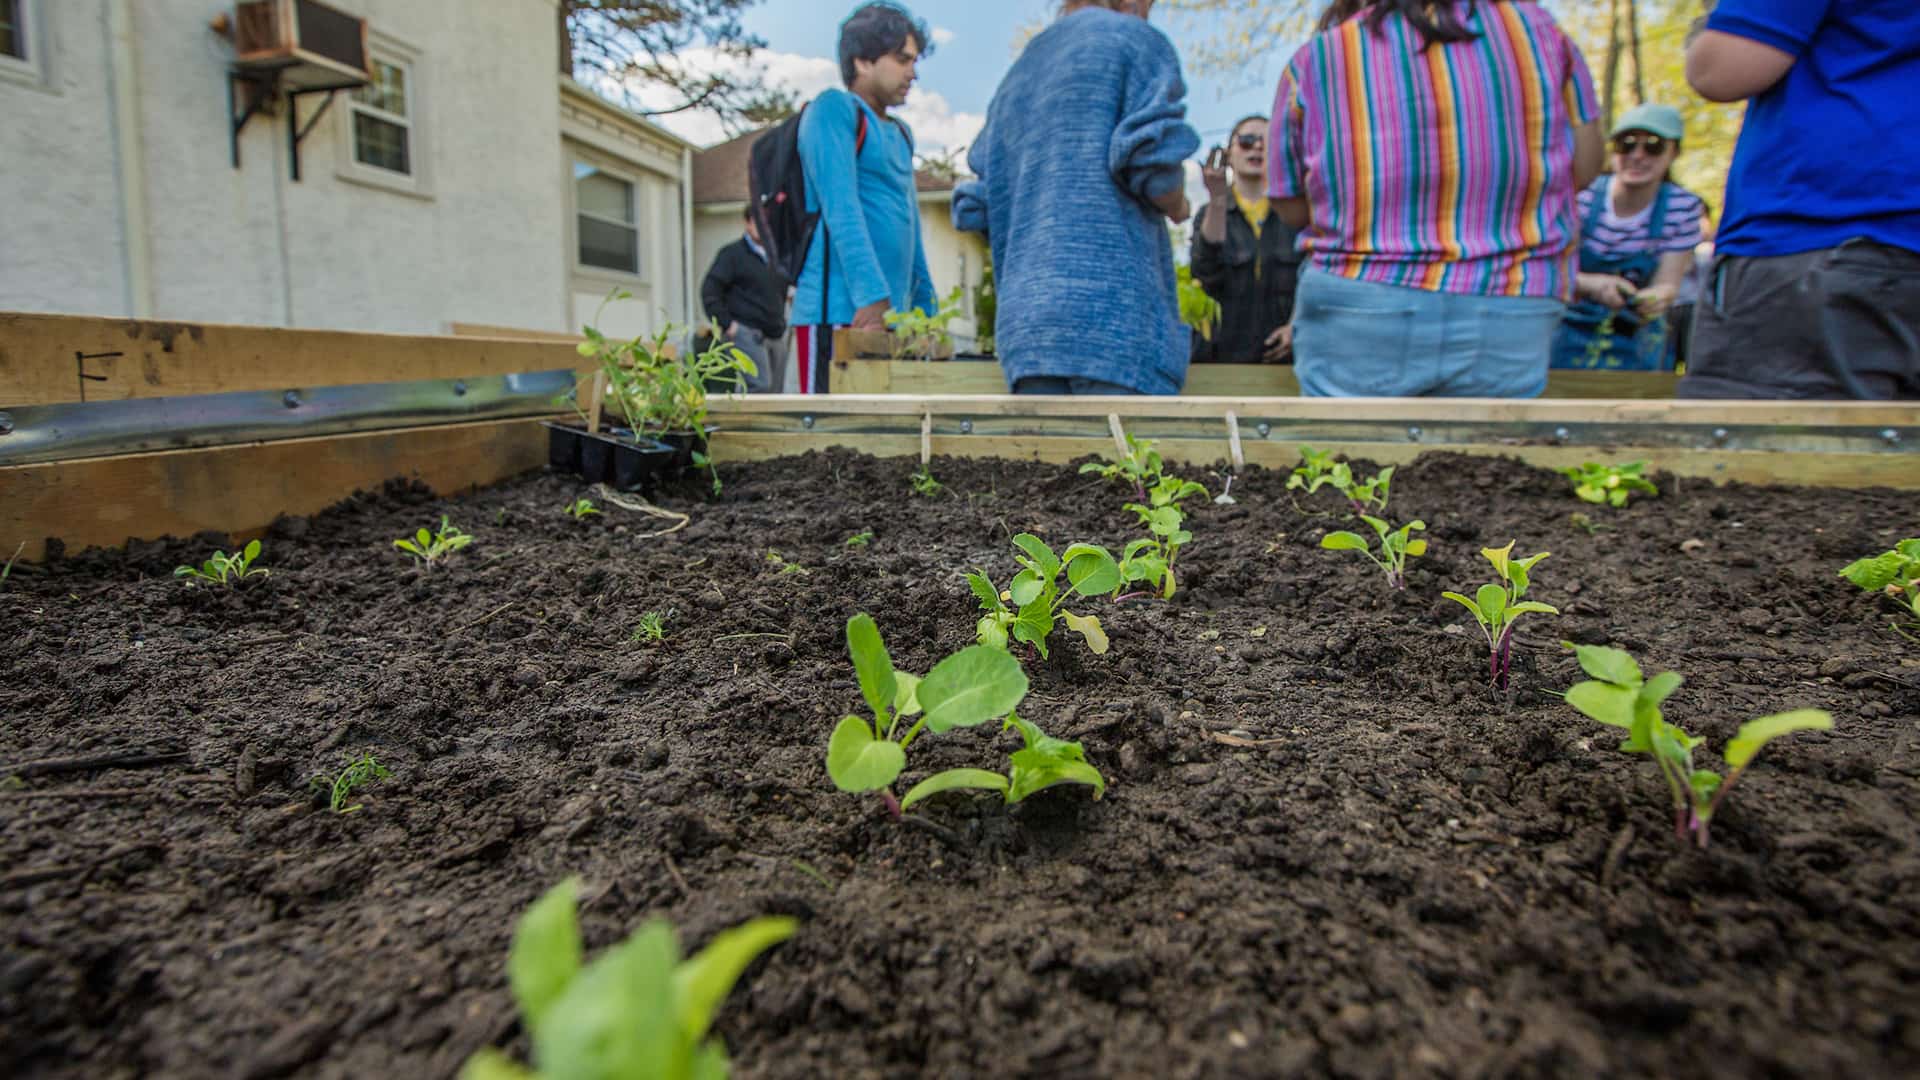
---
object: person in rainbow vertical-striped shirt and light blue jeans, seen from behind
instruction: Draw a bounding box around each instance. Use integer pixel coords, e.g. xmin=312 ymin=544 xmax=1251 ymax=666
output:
xmin=1267 ymin=0 xmax=1605 ymax=398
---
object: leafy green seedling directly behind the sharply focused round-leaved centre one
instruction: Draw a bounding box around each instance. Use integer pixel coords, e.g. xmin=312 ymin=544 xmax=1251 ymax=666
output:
xmin=966 ymin=532 xmax=1121 ymax=659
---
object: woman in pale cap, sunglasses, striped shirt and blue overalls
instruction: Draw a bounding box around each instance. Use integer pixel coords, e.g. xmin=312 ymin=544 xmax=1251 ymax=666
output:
xmin=1553 ymin=104 xmax=1707 ymax=371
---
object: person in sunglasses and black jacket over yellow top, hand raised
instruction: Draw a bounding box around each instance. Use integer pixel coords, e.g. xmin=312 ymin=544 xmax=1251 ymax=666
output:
xmin=1188 ymin=115 xmax=1300 ymax=363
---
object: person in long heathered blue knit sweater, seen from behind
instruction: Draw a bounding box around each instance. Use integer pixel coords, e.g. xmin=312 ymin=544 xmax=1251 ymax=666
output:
xmin=952 ymin=0 xmax=1200 ymax=394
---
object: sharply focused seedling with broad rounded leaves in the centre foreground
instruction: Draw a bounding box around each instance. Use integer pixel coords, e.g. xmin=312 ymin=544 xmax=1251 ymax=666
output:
xmin=828 ymin=611 xmax=1027 ymax=819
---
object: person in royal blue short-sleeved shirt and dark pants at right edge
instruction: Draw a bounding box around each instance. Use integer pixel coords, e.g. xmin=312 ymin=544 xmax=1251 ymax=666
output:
xmin=1680 ymin=0 xmax=1920 ymax=400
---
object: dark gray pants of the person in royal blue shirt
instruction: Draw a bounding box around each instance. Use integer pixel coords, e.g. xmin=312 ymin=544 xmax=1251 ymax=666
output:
xmin=1678 ymin=240 xmax=1920 ymax=400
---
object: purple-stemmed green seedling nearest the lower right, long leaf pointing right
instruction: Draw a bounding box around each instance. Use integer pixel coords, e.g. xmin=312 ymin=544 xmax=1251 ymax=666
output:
xmin=1563 ymin=642 xmax=1834 ymax=847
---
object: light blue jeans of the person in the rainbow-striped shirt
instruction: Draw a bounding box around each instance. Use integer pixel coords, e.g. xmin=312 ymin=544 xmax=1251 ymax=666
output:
xmin=1294 ymin=267 xmax=1567 ymax=398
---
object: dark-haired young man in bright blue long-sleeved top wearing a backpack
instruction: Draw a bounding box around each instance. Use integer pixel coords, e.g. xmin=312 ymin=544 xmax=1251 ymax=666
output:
xmin=793 ymin=2 xmax=935 ymax=394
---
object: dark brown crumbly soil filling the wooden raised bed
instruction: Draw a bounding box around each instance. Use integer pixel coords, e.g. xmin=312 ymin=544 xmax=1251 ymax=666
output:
xmin=0 ymin=443 xmax=1920 ymax=1078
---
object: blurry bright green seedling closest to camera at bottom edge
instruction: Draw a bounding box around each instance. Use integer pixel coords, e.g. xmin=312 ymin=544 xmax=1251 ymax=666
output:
xmin=461 ymin=878 xmax=799 ymax=1080
